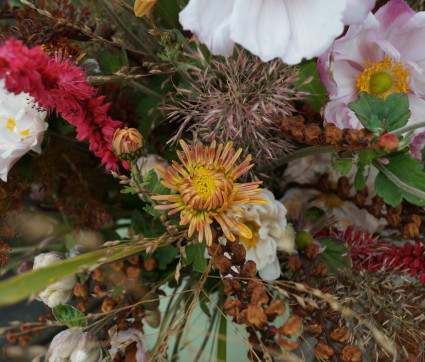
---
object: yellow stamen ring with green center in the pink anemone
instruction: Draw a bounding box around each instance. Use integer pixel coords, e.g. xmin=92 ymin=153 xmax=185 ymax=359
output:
xmin=356 ymin=55 xmax=409 ymax=99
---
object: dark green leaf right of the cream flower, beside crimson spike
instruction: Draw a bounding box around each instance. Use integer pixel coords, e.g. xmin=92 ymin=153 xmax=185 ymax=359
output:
xmin=319 ymin=237 xmax=351 ymax=273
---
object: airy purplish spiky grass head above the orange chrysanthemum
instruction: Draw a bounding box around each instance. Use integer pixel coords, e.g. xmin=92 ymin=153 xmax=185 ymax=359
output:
xmin=164 ymin=49 xmax=307 ymax=173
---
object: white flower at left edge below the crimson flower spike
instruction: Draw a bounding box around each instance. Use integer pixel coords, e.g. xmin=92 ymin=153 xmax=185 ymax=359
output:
xmin=0 ymin=80 xmax=48 ymax=182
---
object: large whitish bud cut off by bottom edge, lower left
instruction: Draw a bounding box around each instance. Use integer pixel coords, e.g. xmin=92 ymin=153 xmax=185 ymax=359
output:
xmin=47 ymin=329 xmax=102 ymax=362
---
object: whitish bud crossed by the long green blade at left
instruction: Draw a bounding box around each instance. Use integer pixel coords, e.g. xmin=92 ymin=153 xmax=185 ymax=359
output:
xmin=33 ymin=251 xmax=76 ymax=308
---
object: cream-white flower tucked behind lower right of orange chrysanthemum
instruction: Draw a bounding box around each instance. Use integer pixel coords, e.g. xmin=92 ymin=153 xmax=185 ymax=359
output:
xmin=239 ymin=189 xmax=295 ymax=280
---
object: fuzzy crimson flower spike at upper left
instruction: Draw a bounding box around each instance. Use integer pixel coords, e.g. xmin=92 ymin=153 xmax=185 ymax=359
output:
xmin=0 ymin=39 xmax=122 ymax=170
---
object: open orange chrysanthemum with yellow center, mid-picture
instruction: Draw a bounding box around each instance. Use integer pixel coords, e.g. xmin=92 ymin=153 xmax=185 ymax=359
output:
xmin=152 ymin=140 xmax=267 ymax=245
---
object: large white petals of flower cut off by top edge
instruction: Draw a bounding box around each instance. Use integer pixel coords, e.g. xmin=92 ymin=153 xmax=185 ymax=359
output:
xmin=180 ymin=0 xmax=375 ymax=64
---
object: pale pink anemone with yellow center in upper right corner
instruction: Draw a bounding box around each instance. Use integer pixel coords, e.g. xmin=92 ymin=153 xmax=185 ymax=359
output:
xmin=317 ymin=0 xmax=425 ymax=158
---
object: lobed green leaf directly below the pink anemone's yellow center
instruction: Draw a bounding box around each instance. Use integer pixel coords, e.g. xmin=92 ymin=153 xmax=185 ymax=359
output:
xmin=348 ymin=92 xmax=410 ymax=134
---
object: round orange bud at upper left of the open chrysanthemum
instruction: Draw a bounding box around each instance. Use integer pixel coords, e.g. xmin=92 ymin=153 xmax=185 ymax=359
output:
xmin=112 ymin=127 xmax=143 ymax=161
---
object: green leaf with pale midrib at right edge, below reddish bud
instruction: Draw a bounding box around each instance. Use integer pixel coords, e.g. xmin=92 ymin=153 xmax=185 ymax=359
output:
xmin=375 ymin=154 xmax=425 ymax=206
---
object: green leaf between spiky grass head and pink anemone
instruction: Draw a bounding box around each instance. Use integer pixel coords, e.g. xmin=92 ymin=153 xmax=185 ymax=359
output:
xmin=296 ymin=61 xmax=327 ymax=112
